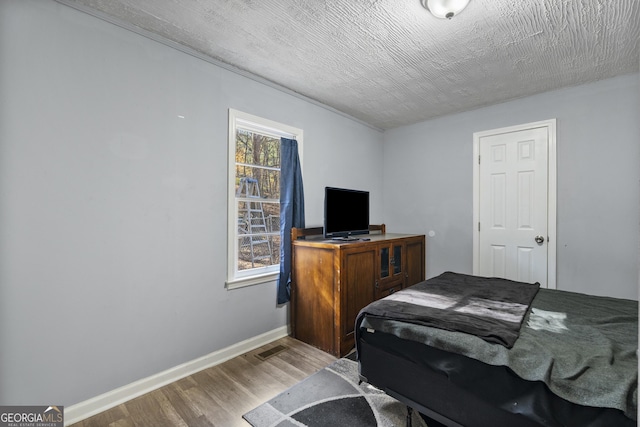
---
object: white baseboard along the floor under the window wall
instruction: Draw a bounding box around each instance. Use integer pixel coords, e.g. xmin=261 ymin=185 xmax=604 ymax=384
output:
xmin=64 ymin=326 xmax=289 ymax=426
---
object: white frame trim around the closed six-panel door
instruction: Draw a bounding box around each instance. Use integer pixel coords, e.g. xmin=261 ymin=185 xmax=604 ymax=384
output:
xmin=473 ymin=119 xmax=557 ymax=289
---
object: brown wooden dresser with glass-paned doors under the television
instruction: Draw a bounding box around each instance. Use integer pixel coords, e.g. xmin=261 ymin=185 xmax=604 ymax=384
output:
xmin=291 ymin=225 xmax=425 ymax=357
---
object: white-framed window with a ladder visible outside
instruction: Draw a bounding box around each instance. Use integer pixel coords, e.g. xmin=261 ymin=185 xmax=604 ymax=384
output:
xmin=227 ymin=109 xmax=302 ymax=289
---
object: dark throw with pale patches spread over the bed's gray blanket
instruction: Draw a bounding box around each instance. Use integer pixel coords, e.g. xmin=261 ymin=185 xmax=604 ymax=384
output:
xmin=356 ymin=272 xmax=540 ymax=348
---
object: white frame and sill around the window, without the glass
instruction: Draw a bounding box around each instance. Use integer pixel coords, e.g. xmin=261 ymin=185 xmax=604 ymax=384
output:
xmin=226 ymin=108 xmax=303 ymax=289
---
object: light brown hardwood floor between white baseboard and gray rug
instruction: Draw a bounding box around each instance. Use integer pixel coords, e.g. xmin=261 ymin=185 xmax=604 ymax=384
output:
xmin=72 ymin=337 xmax=336 ymax=427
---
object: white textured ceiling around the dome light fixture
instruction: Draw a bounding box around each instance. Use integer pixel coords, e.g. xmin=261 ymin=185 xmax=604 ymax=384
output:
xmin=59 ymin=0 xmax=640 ymax=129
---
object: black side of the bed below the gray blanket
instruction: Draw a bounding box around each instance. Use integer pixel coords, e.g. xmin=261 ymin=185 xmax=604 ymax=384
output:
xmin=357 ymin=314 xmax=637 ymax=427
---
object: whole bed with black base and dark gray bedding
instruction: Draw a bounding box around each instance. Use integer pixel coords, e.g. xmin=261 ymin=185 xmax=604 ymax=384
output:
xmin=356 ymin=272 xmax=638 ymax=427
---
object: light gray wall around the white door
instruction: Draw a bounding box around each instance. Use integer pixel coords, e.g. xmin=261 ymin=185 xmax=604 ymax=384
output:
xmin=383 ymin=74 xmax=640 ymax=299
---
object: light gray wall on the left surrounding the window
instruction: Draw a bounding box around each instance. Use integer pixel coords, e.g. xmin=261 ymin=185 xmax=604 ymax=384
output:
xmin=0 ymin=1 xmax=382 ymax=405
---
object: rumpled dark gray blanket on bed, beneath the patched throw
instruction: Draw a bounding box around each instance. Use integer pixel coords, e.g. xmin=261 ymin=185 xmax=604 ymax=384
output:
xmin=362 ymin=289 xmax=638 ymax=419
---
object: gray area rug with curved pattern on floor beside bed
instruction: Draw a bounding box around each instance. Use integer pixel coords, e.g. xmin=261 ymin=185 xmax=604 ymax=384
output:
xmin=242 ymin=359 xmax=427 ymax=427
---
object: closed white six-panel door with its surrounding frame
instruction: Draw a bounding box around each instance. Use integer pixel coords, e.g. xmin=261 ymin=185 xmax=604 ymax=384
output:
xmin=474 ymin=121 xmax=555 ymax=287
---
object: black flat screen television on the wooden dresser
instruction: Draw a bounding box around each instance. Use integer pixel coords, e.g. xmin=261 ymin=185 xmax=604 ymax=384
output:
xmin=324 ymin=187 xmax=369 ymax=239
